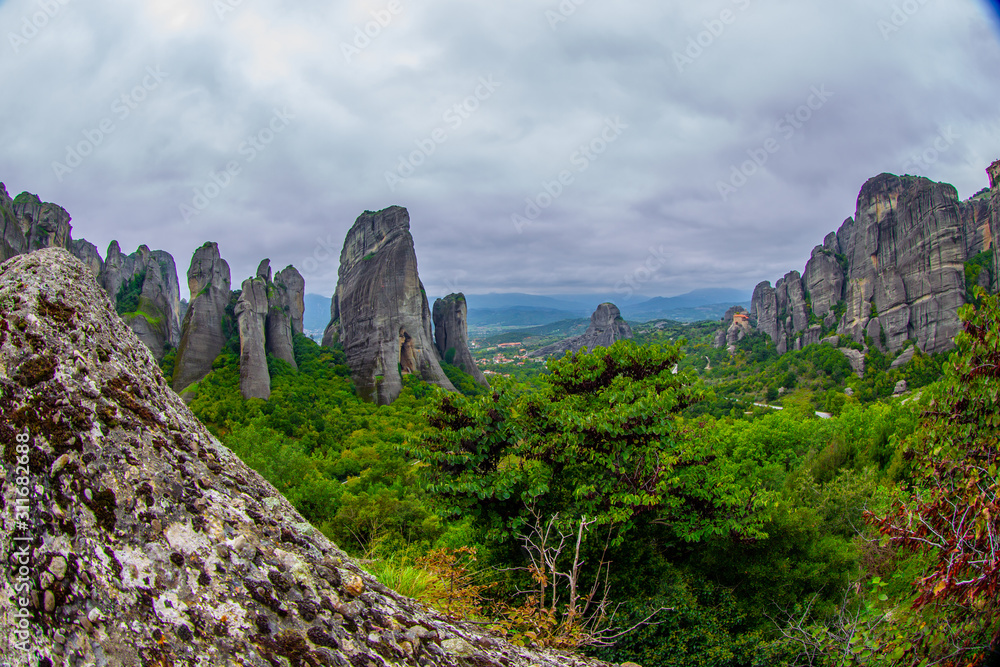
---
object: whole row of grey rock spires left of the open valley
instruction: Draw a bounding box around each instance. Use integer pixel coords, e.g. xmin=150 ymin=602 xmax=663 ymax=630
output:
xmin=0 ymin=184 xmax=487 ymax=404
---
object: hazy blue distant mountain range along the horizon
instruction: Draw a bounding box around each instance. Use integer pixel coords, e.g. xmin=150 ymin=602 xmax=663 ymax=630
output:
xmin=304 ymin=288 xmax=751 ymax=332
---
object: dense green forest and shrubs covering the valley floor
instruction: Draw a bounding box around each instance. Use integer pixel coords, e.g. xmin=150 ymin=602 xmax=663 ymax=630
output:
xmin=164 ymin=293 xmax=1000 ymax=667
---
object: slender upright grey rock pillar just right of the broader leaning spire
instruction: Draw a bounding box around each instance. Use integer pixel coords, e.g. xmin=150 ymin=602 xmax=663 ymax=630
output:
xmin=236 ymin=277 xmax=271 ymax=400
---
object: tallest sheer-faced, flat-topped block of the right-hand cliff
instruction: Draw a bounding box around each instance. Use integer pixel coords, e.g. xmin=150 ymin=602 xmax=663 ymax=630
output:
xmin=841 ymin=174 xmax=965 ymax=353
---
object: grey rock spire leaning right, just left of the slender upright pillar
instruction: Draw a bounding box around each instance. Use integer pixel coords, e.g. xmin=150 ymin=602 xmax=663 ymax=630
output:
xmin=173 ymin=242 xmax=230 ymax=393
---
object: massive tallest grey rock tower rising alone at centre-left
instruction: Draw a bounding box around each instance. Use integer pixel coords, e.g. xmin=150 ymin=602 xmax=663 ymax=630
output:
xmin=323 ymin=206 xmax=455 ymax=405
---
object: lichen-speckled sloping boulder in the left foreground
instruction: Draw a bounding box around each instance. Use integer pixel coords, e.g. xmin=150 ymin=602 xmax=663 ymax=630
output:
xmin=0 ymin=250 xmax=594 ymax=667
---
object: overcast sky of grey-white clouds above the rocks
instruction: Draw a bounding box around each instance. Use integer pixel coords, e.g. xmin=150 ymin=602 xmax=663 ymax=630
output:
xmin=0 ymin=0 xmax=1000 ymax=300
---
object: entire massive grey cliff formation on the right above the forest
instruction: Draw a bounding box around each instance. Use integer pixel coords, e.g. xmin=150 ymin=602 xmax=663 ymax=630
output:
xmin=750 ymin=162 xmax=1000 ymax=353
